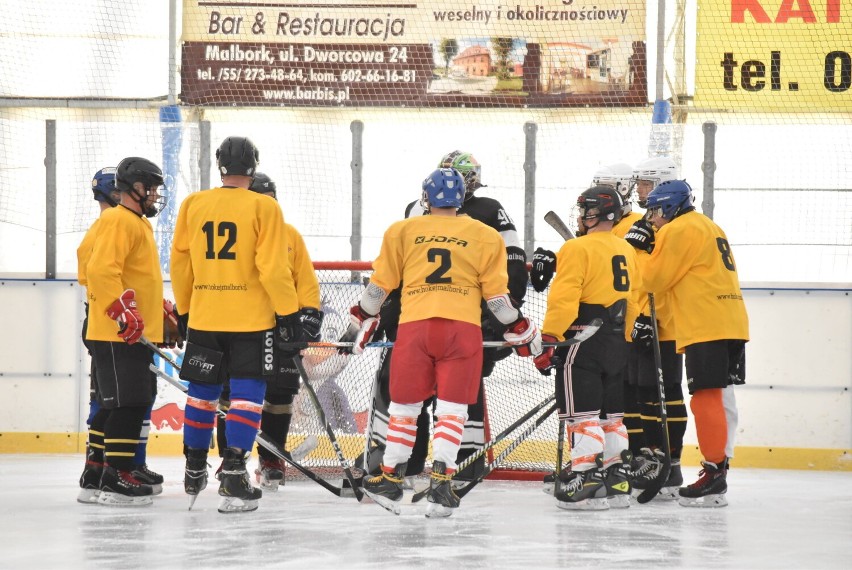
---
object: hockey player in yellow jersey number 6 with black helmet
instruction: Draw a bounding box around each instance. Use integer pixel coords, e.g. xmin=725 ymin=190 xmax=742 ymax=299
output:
xmin=535 ymin=186 xmax=640 ymax=510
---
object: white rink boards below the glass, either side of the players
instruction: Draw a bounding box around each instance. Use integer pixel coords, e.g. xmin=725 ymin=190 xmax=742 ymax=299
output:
xmin=0 ymin=278 xmax=852 ymax=449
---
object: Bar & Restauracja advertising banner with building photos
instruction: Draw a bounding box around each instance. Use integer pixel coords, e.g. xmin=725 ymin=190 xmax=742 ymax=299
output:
xmin=181 ymin=0 xmax=647 ymax=107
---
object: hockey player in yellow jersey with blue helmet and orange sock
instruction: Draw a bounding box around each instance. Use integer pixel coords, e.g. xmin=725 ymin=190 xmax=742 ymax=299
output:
xmin=626 ymin=180 xmax=748 ymax=507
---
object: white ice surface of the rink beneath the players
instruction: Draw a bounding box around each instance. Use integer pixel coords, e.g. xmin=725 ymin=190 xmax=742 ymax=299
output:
xmin=0 ymin=455 xmax=852 ymax=570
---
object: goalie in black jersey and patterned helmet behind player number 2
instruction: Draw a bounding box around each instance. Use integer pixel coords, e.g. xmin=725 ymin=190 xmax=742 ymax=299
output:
xmin=358 ymin=150 xmax=528 ymax=481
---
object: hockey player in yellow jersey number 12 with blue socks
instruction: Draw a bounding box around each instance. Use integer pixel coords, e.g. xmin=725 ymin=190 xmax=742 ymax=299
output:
xmin=171 ymin=137 xmax=303 ymax=512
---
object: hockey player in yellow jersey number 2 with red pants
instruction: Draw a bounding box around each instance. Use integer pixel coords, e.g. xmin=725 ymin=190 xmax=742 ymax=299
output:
xmin=348 ymin=168 xmax=541 ymax=517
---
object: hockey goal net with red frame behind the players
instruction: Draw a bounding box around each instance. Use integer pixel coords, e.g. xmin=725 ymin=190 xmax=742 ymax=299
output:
xmin=287 ymin=261 xmax=558 ymax=479
